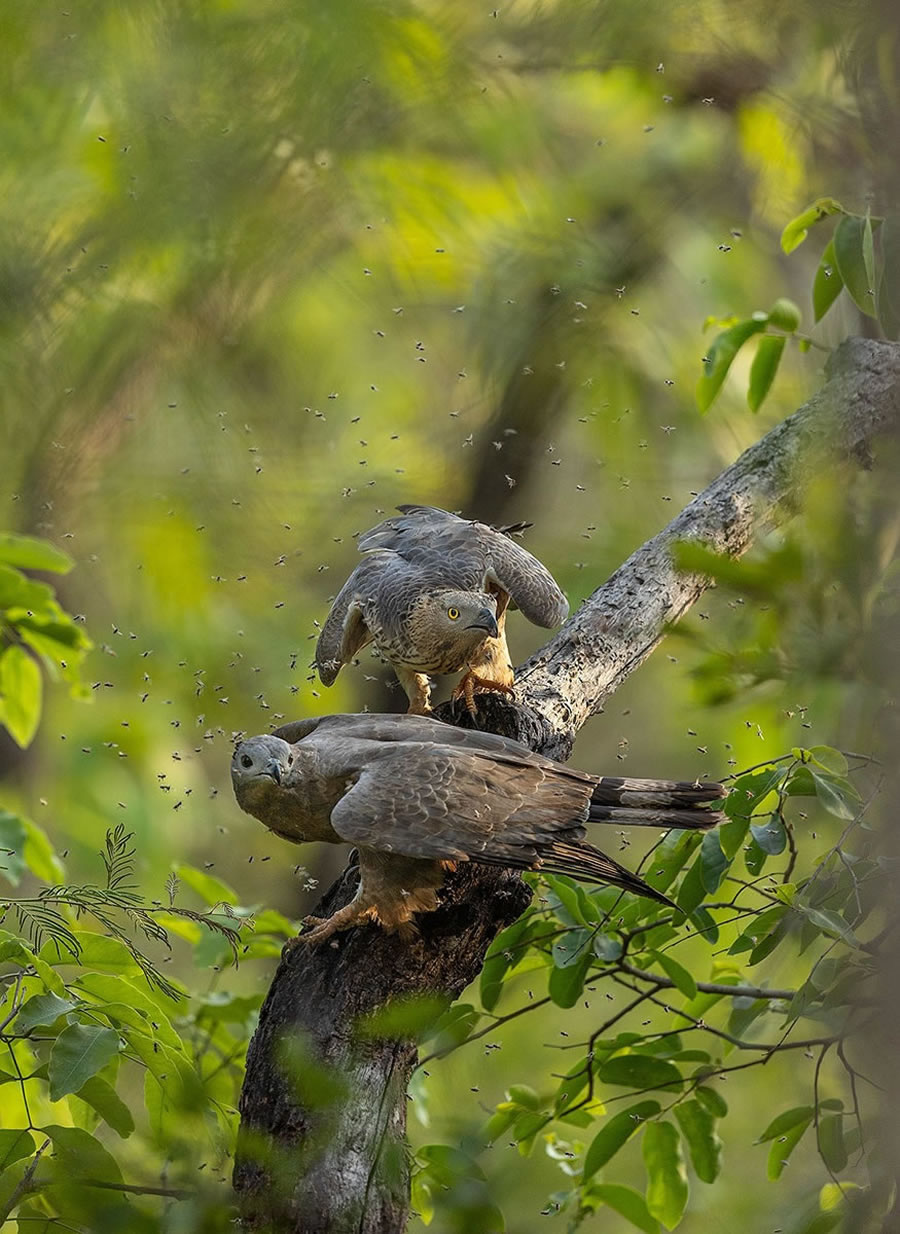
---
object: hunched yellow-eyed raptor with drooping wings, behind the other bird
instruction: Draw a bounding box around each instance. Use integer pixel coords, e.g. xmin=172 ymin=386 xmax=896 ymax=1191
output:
xmin=316 ymin=506 xmax=569 ymax=714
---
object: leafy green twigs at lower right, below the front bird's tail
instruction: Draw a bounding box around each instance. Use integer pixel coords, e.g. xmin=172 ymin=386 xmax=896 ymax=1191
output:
xmin=415 ymin=747 xmax=886 ymax=1234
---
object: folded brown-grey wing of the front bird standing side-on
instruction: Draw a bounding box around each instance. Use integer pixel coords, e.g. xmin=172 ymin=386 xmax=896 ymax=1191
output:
xmin=331 ymin=743 xmax=668 ymax=903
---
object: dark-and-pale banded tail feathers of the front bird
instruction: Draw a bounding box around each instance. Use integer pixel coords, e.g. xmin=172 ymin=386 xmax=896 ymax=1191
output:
xmin=588 ymin=776 xmax=727 ymax=830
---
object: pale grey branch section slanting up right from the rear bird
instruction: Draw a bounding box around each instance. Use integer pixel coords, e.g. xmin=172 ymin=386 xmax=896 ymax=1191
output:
xmin=516 ymin=338 xmax=900 ymax=759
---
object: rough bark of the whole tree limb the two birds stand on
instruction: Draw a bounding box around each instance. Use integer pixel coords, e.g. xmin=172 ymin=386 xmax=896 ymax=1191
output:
xmin=235 ymin=339 xmax=900 ymax=1234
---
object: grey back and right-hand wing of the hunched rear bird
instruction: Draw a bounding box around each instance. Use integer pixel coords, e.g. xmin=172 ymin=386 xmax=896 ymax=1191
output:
xmin=358 ymin=506 xmax=569 ymax=629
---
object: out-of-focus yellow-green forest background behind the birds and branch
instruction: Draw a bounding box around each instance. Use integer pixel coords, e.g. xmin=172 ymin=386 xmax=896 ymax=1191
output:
xmin=0 ymin=0 xmax=898 ymax=1234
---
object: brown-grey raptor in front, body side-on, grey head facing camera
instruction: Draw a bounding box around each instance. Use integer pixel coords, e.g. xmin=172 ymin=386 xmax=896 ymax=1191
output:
xmin=231 ymin=714 xmax=726 ymax=943
